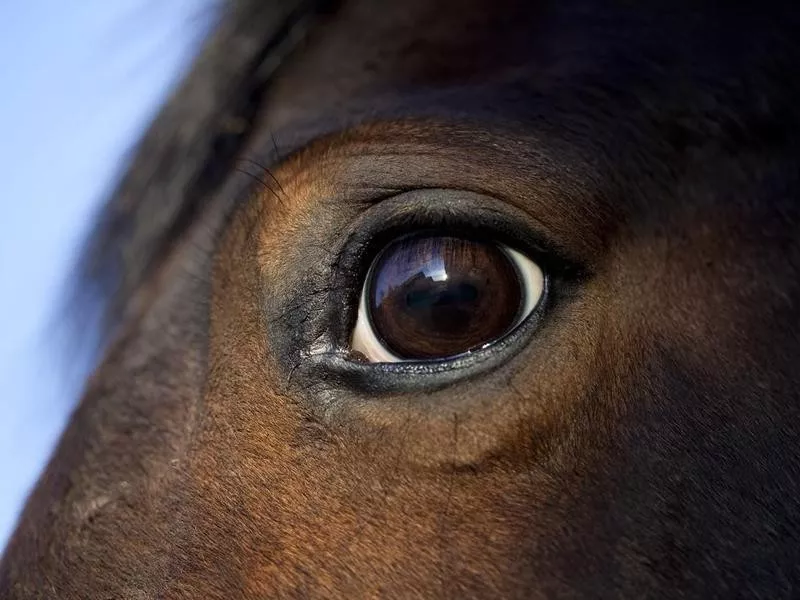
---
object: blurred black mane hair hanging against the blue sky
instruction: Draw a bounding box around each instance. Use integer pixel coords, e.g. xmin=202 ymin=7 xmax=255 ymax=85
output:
xmin=74 ymin=0 xmax=333 ymax=350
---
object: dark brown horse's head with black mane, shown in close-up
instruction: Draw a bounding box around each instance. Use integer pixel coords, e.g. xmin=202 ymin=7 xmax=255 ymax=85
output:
xmin=0 ymin=0 xmax=800 ymax=599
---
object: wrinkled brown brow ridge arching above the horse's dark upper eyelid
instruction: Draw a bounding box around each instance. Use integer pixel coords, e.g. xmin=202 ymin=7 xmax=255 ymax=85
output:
xmin=256 ymin=120 xmax=614 ymax=265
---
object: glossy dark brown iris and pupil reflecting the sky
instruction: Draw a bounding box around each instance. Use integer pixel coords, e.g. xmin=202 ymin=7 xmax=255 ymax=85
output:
xmin=367 ymin=237 xmax=524 ymax=359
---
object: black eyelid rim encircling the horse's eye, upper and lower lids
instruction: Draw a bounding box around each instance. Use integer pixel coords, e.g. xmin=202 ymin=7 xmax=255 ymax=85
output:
xmin=296 ymin=188 xmax=589 ymax=393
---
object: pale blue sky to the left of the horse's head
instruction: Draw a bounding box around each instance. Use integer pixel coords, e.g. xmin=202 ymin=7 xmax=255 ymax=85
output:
xmin=0 ymin=0 xmax=215 ymax=548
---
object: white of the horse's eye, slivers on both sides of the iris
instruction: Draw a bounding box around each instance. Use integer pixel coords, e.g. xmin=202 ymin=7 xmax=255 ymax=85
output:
xmin=350 ymin=246 xmax=544 ymax=363
